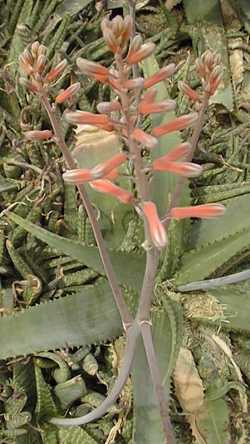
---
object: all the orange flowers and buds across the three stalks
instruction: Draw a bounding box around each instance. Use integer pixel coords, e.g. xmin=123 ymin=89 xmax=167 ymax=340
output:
xmin=20 ymin=16 xmax=224 ymax=248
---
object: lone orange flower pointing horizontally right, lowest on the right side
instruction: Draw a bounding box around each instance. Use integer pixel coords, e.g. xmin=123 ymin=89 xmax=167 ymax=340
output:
xmin=170 ymin=204 xmax=226 ymax=219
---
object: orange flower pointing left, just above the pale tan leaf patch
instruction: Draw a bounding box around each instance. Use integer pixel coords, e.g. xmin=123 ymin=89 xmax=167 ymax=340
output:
xmin=65 ymin=111 xmax=113 ymax=131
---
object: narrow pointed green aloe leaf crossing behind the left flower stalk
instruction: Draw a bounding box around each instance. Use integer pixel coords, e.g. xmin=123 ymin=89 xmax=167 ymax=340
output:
xmin=8 ymin=213 xmax=145 ymax=289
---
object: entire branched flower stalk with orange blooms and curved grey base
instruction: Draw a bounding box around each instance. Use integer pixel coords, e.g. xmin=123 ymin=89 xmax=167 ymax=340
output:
xmin=20 ymin=9 xmax=224 ymax=444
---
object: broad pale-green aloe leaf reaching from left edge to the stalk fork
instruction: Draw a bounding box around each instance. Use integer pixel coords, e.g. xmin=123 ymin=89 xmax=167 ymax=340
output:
xmin=0 ymin=280 xmax=122 ymax=359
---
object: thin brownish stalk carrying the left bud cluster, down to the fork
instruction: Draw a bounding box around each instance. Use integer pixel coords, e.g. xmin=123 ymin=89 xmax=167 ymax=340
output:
xmin=41 ymin=94 xmax=133 ymax=331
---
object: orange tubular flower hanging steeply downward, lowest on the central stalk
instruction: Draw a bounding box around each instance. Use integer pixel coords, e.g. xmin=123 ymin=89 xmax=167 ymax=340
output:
xmin=143 ymin=202 xmax=167 ymax=248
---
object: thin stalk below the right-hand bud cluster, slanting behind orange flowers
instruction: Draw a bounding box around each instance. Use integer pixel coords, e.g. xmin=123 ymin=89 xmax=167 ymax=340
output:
xmin=162 ymin=93 xmax=210 ymax=230
